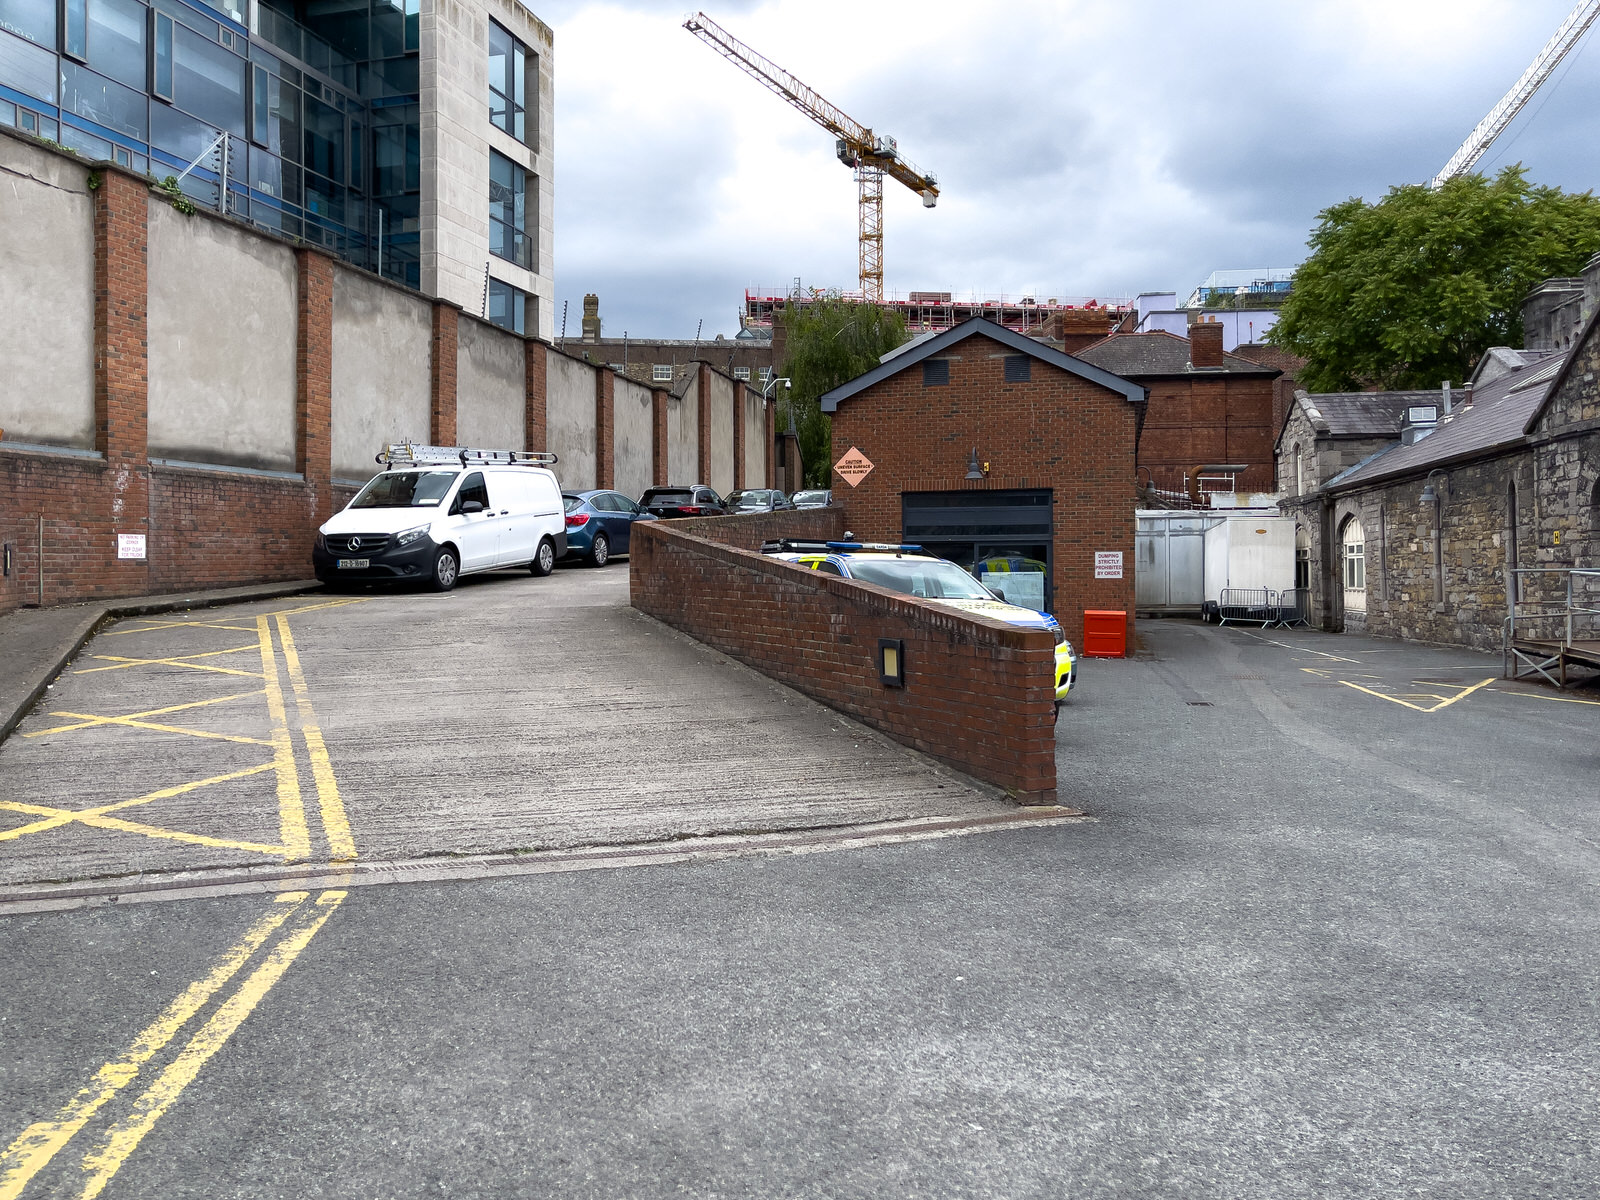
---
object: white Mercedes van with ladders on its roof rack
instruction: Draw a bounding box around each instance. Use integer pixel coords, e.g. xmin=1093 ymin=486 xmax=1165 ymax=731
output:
xmin=312 ymin=443 xmax=566 ymax=592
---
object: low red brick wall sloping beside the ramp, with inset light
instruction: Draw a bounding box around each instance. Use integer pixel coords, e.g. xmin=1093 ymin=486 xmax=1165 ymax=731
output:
xmin=629 ymin=514 xmax=1056 ymax=805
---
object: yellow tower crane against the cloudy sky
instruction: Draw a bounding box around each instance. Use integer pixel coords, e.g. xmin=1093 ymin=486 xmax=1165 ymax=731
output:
xmin=683 ymin=13 xmax=939 ymax=304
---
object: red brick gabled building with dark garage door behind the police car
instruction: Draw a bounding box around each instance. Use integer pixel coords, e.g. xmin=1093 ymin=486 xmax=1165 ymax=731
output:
xmin=822 ymin=318 xmax=1146 ymax=645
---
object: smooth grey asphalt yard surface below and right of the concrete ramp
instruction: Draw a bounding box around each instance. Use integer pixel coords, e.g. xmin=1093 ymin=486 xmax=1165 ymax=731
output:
xmin=0 ymin=622 xmax=1600 ymax=1200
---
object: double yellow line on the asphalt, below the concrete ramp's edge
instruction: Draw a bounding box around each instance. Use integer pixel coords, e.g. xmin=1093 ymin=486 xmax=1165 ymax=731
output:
xmin=0 ymin=891 xmax=346 ymax=1200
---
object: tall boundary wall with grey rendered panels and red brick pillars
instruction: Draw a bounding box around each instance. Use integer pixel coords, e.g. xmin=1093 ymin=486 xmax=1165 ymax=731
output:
xmin=0 ymin=130 xmax=771 ymax=613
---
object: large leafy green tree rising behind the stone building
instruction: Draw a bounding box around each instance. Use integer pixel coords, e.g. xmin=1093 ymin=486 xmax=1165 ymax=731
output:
xmin=1267 ymin=165 xmax=1600 ymax=392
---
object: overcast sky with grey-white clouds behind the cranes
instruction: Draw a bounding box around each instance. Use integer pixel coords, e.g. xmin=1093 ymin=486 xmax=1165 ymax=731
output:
xmin=533 ymin=0 xmax=1600 ymax=338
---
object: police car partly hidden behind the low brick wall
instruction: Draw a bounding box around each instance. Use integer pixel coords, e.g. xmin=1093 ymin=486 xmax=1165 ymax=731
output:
xmin=762 ymin=539 xmax=1077 ymax=710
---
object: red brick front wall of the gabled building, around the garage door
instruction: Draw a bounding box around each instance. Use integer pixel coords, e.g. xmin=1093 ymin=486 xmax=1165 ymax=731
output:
xmin=832 ymin=336 xmax=1136 ymax=646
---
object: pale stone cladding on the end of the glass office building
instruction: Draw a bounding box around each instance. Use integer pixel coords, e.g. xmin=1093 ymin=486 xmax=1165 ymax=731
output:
xmin=419 ymin=0 xmax=555 ymax=339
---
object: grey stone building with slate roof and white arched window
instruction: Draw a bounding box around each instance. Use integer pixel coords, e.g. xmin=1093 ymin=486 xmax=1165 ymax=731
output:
xmin=1277 ymin=312 xmax=1600 ymax=650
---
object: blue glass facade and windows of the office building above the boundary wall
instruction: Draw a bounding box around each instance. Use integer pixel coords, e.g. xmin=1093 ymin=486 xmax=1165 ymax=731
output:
xmin=0 ymin=0 xmax=547 ymax=333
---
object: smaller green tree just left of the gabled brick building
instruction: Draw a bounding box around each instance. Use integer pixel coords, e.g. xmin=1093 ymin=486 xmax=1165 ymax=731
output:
xmin=778 ymin=293 xmax=906 ymax=488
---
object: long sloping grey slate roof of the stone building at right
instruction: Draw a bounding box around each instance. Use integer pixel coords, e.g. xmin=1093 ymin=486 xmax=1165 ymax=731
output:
xmin=1328 ymin=350 xmax=1573 ymax=491
